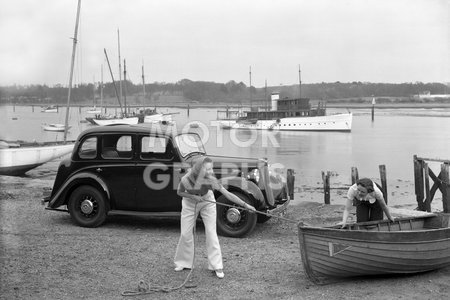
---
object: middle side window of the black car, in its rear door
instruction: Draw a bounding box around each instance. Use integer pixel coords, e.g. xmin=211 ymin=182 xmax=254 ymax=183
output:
xmin=102 ymin=134 xmax=133 ymax=159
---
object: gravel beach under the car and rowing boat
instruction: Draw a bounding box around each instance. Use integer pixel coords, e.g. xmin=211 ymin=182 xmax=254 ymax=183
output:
xmin=0 ymin=161 xmax=450 ymax=300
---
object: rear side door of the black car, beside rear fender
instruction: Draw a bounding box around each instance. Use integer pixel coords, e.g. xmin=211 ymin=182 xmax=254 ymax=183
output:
xmin=99 ymin=133 xmax=136 ymax=210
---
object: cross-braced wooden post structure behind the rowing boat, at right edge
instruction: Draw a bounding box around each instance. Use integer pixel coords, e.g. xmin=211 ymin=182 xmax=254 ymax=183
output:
xmin=414 ymin=155 xmax=450 ymax=213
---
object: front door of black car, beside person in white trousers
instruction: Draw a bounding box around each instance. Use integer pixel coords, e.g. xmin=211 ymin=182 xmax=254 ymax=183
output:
xmin=136 ymin=134 xmax=186 ymax=212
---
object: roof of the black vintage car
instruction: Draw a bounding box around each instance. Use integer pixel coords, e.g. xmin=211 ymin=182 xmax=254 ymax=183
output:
xmin=80 ymin=123 xmax=180 ymax=137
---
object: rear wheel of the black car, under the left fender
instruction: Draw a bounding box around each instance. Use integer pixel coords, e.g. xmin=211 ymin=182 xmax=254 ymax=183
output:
xmin=68 ymin=185 xmax=107 ymax=227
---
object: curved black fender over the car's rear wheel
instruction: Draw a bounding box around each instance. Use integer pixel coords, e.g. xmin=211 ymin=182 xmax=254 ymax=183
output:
xmin=47 ymin=172 xmax=110 ymax=208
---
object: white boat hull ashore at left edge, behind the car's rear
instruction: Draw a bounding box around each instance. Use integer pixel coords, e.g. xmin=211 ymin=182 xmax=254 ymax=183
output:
xmin=0 ymin=142 xmax=74 ymax=176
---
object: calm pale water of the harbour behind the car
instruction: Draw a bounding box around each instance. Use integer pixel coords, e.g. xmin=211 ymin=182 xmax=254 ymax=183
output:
xmin=0 ymin=106 xmax=450 ymax=202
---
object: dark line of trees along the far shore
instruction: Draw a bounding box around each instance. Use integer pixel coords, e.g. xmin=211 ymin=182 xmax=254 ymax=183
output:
xmin=0 ymin=79 xmax=450 ymax=104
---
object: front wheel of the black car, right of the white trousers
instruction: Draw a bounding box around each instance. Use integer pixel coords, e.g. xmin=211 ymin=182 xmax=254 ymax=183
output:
xmin=217 ymin=192 xmax=257 ymax=237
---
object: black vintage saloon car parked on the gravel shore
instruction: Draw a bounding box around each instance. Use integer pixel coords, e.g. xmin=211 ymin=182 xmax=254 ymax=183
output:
xmin=44 ymin=124 xmax=293 ymax=237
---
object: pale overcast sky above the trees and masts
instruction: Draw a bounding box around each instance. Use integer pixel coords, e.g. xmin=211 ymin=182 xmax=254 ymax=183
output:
xmin=0 ymin=0 xmax=450 ymax=87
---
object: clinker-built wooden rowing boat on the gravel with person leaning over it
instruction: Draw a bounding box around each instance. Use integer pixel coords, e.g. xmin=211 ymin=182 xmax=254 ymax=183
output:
xmin=298 ymin=214 xmax=450 ymax=283
